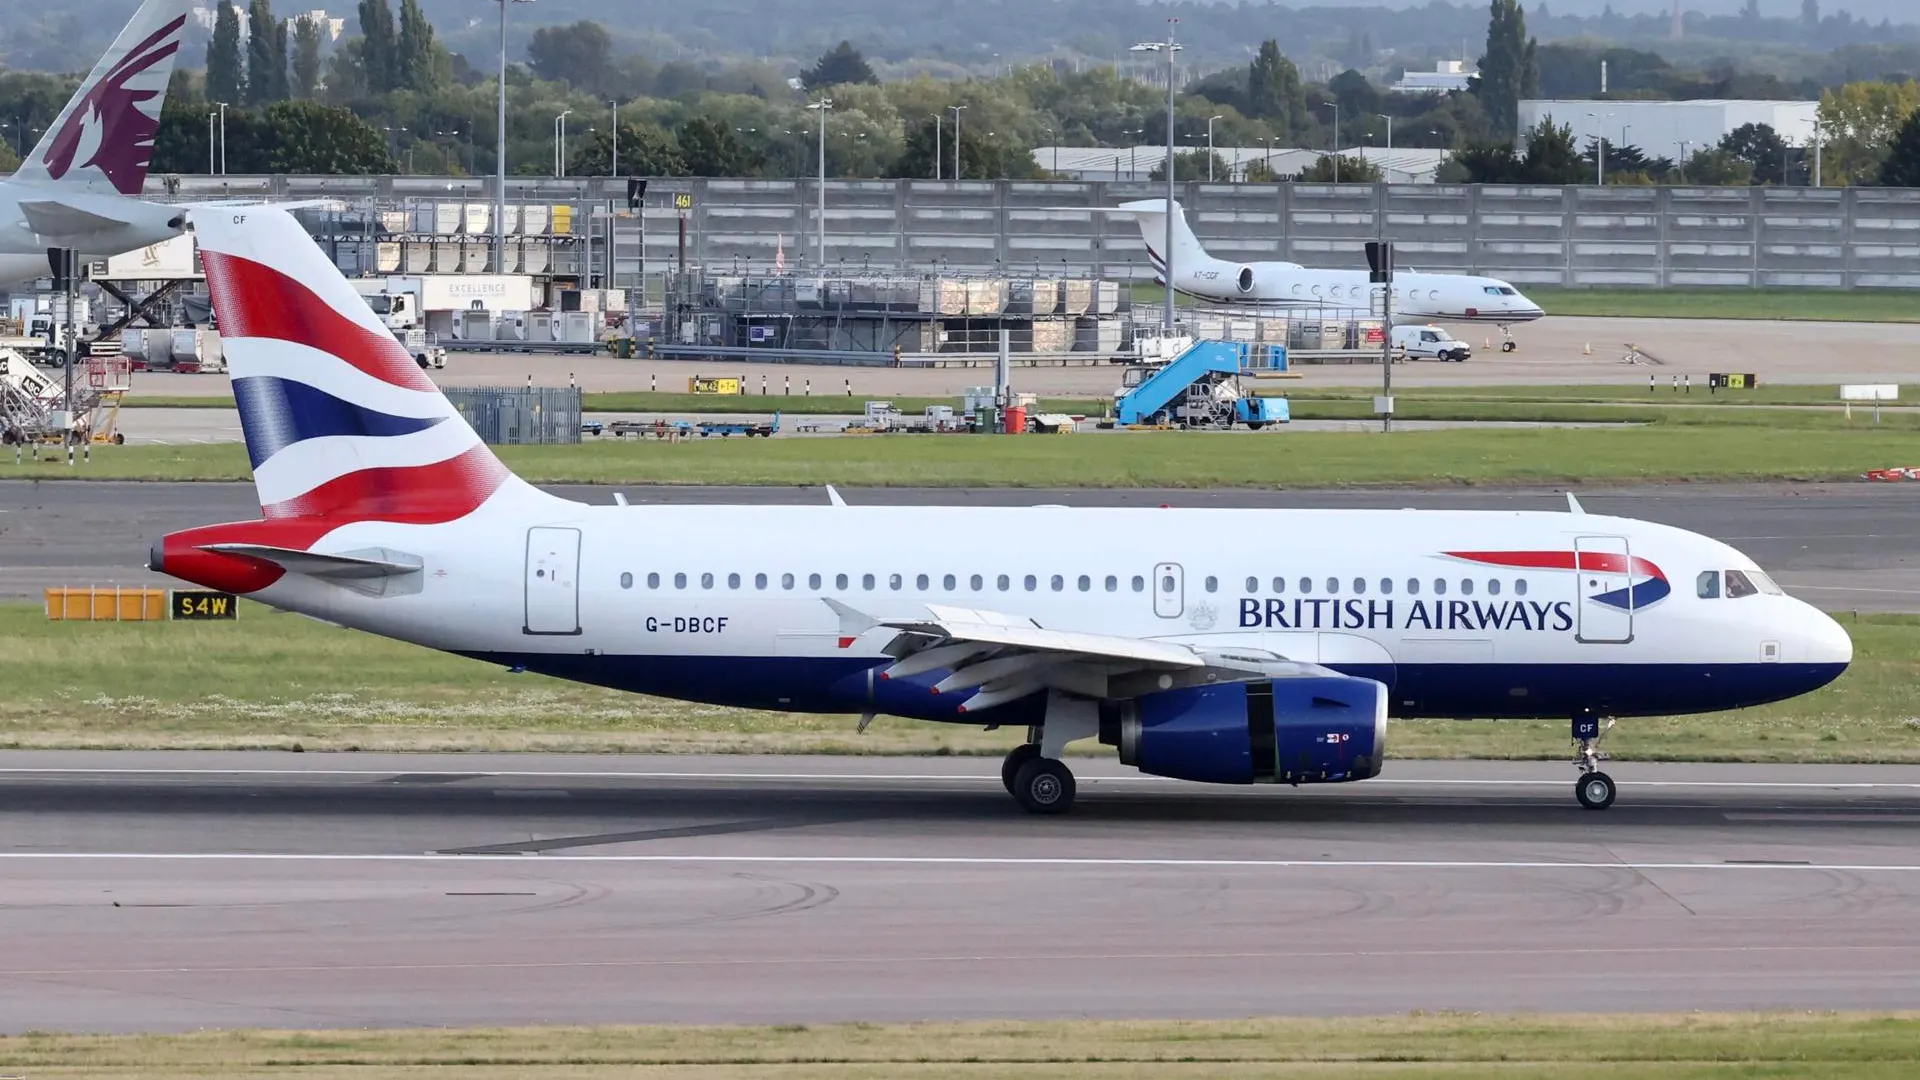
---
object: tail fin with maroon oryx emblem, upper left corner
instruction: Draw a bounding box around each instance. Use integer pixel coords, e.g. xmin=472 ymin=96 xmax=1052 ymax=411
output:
xmin=13 ymin=0 xmax=192 ymax=196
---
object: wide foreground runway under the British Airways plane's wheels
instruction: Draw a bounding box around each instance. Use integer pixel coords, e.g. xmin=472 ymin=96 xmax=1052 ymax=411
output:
xmin=0 ymin=751 xmax=1920 ymax=1034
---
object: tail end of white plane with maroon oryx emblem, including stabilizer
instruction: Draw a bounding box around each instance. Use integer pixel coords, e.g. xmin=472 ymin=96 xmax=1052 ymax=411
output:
xmin=0 ymin=0 xmax=192 ymax=284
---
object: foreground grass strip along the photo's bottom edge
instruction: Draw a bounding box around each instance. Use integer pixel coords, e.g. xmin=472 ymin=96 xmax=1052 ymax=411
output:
xmin=0 ymin=1013 xmax=1920 ymax=1080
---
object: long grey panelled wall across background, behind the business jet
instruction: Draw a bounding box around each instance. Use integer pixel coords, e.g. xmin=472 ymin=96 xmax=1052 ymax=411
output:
xmin=161 ymin=177 xmax=1920 ymax=288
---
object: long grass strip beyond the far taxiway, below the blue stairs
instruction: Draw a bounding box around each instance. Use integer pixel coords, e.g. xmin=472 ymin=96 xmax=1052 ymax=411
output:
xmin=0 ymin=420 xmax=1920 ymax=488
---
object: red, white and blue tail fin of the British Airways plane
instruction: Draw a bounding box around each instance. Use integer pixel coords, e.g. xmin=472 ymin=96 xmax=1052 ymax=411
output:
xmin=192 ymin=206 xmax=559 ymax=525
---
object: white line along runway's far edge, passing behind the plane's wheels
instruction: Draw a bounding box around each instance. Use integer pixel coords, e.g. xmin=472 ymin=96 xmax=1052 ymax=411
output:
xmin=0 ymin=767 xmax=1920 ymax=792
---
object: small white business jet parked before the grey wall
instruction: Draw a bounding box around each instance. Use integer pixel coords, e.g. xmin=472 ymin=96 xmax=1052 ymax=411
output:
xmin=1117 ymin=198 xmax=1546 ymax=352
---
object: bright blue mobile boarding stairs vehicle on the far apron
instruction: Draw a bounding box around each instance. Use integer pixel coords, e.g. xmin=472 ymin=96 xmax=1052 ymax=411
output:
xmin=1114 ymin=340 xmax=1288 ymax=429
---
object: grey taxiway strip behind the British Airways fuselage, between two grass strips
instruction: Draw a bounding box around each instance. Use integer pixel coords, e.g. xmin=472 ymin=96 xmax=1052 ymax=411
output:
xmin=0 ymin=480 xmax=1920 ymax=611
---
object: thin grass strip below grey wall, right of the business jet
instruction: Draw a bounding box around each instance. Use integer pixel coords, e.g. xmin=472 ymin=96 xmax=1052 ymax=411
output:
xmin=1523 ymin=284 xmax=1920 ymax=323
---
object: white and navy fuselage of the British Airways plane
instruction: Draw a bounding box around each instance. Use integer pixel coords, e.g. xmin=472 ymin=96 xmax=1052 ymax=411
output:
xmin=169 ymin=500 xmax=1851 ymax=724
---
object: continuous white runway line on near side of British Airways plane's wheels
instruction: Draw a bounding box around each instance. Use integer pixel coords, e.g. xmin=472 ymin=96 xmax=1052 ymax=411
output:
xmin=11 ymin=851 xmax=1920 ymax=874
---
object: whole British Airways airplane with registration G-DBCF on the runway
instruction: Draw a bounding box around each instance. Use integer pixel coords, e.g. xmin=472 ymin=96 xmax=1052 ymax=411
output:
xmin=150 ymin=208 xmax=1853 ymax=813
